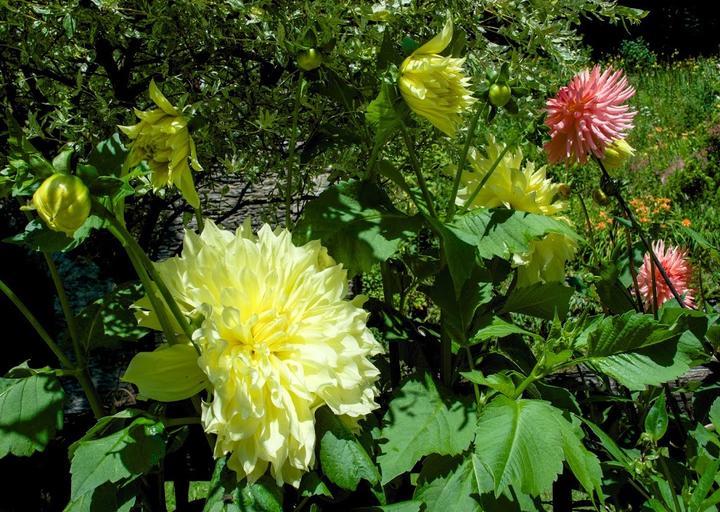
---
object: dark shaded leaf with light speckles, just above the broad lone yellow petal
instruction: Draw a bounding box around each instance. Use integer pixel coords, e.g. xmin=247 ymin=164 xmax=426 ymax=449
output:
xmin=77 ymin=283 xmax=149 ymax=351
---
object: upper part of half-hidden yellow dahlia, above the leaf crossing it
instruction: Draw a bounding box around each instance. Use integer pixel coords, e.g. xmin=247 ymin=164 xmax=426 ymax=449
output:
xmin=462 ymin=136 xmax=567 ymax=215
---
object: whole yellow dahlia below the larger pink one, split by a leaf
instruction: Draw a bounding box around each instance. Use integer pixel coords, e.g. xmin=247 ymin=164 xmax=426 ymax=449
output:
xmin=455 ymin=137 xmax=577 ymax=286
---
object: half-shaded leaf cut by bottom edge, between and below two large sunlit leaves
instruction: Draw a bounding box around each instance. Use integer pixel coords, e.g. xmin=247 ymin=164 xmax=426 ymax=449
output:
xmin=413 ymin=456 xmax=483 ymax=512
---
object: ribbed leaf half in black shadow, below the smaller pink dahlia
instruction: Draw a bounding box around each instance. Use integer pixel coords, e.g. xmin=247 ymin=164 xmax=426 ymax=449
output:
xmin=584 ymin=312 xmax=703 ymax=390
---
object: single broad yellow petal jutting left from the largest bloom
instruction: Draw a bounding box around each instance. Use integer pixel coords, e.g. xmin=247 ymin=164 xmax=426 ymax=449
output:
xmin=122 ymin=344 xmax=208 ymax=402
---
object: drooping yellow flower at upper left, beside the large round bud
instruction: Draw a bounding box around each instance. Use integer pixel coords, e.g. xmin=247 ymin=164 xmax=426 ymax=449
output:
xmin=119 ymin=80 xmax=202 ymax=208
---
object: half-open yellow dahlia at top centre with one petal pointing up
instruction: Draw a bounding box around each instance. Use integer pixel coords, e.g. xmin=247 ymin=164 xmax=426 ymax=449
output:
xmin=399 ymin=17 xmax=475 ymax=137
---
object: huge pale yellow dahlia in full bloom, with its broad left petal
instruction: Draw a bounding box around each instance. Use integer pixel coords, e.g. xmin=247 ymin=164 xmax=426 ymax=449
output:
xmin=124 ymin=221 xmax=382 ymax=486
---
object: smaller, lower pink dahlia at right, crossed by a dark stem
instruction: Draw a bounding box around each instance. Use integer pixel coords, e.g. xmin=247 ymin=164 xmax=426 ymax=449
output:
xmin=638 ymin=240 xmax=695 ymax=309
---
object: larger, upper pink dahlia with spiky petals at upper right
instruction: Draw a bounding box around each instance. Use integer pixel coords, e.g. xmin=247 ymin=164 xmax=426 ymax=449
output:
xmin=545 ymin=66 xmax=636 ymax=163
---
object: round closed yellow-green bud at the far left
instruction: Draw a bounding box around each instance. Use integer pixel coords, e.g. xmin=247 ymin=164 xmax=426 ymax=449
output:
xmin=33 ymin=174 xmax=90 ymax=236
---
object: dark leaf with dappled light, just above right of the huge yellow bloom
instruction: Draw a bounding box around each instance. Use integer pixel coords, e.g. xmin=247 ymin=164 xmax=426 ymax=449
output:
xmin=295 ymin=181 xmax=421 ymax=273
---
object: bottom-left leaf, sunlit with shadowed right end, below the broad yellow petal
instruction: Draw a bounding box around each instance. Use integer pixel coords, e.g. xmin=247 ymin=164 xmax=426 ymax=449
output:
xmin=70 ymin=417 xmax=165 ymax=500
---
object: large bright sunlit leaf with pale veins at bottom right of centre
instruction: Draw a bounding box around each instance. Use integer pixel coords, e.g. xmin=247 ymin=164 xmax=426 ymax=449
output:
xmin=475 ymin=395 xmax=601 ymax=496
